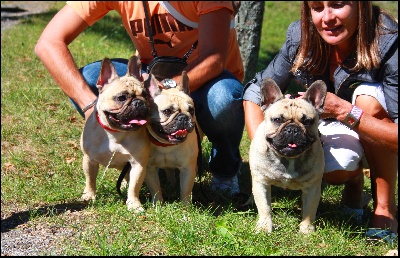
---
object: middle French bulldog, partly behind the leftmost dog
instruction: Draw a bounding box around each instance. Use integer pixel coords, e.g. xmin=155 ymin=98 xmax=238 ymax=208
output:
xmin=145 ymin=72 xmax=201 ymax=205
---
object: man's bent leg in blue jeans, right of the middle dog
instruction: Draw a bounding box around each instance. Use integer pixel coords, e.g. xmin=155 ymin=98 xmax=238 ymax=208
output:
xmin=191 ymin=70 xmax=244 ymax=194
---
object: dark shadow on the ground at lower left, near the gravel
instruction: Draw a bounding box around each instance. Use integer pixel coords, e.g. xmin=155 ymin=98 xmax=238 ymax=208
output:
xmin=1 ymin=202 xmax=87 ymax=233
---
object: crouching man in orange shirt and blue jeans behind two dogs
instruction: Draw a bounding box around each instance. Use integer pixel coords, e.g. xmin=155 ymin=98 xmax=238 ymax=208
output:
xmin=35 ymin=1 xmax=244 ymax=194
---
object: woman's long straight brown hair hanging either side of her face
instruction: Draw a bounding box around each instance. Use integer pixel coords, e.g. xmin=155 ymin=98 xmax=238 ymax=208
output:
xmin=291 ymin=1 xmax=397 ymax=75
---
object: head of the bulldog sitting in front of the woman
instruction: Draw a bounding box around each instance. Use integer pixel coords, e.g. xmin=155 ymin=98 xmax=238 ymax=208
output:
xmin=261 ymin=80 xmax=326 ymax=158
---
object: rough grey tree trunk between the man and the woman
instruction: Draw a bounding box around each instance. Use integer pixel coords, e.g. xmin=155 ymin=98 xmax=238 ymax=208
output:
xmin=235 ymin=1 xmax=265 ymax=84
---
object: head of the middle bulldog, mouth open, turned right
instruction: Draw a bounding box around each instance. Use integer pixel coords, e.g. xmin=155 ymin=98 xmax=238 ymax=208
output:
xmin=147 ymin=72 xmax=196 ymax=144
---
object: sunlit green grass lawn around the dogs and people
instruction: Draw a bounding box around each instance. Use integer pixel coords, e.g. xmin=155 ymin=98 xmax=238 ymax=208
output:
xmin=1 ymin=2 xmax=397 ymax=255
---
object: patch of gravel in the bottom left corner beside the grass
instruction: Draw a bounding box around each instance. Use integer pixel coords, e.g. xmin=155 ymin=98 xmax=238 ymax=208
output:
xmin=1 ymin=202 xmax=87 ymax=256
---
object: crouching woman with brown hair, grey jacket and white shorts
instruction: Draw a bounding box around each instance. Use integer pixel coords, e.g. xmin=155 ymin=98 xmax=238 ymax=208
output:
xmin=243 ymin=1 xmax=398 ymax=241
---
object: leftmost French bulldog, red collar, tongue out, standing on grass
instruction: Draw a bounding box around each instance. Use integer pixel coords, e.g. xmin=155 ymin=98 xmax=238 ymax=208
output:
xmin=81 ymin=56 xmax=155 ymax=211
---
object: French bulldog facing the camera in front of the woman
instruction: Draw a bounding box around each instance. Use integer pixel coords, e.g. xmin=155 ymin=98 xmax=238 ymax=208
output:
xmin=249 ymin=79 xmax=327 ymax=234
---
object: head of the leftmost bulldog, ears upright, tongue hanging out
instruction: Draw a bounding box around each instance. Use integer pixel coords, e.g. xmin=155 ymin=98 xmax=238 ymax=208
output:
xmin=97 ymin=56 xmax=155 ymax=131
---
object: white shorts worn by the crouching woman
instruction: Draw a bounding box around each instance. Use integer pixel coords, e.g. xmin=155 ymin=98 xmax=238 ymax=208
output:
xmin=318 ymin=83 xmax=387 ymax=173
